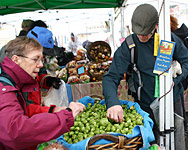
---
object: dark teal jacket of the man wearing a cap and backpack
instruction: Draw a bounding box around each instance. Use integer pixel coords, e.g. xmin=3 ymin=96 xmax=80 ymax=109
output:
xmin=103 ymin=33 xmax=188 ymax=108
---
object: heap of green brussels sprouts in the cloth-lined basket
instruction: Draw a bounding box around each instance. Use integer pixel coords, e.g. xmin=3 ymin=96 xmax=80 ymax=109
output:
xmin=64 ymin=101 xmax=143 ymax=144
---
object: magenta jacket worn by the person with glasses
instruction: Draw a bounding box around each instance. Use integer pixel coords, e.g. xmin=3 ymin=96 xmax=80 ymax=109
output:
xmin=0 ymin=57 xmax=74 ymax=150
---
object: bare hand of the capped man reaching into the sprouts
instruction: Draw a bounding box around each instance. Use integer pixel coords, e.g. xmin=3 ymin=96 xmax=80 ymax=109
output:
xmin=107 ymin=105 xmax=124 ymax=123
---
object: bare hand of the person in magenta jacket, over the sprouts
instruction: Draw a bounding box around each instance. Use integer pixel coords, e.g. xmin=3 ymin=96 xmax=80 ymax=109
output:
xmin=69 ymin=102 xmax=85 ymax=119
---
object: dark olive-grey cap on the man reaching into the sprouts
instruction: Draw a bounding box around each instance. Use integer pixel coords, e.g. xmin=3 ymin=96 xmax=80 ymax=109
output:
xmin=131 ymin=4 xmax=159 ymax=35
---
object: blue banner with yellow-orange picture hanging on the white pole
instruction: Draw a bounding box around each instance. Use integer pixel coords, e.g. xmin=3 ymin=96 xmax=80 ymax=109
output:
xmin=153 ymin=40 xmax=176 ymax=75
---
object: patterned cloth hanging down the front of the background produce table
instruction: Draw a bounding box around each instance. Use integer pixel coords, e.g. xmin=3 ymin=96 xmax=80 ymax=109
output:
xmin=71 ymin=80 xmax=133 ymax=101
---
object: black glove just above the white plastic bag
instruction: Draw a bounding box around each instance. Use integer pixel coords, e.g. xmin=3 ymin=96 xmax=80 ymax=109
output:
xmin=46 ymin=77 xmax=62 ymax=89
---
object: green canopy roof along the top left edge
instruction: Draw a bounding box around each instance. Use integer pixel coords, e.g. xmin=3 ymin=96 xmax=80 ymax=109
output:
xmin=0 ymin=0 xmax=124 ymax=15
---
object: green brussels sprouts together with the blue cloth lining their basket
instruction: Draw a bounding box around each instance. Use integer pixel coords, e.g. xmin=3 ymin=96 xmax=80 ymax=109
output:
xmin=57 ymin=96 xmax=154 ymax=150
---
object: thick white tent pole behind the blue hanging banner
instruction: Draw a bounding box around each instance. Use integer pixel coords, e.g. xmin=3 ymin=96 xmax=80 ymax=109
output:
xmin=158 ymin=0 xmax=174 ymax=150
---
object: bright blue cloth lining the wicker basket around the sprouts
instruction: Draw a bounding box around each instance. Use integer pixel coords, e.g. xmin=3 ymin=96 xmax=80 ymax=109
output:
xmin=57 ymin=96 xmax=155 ymax=150
